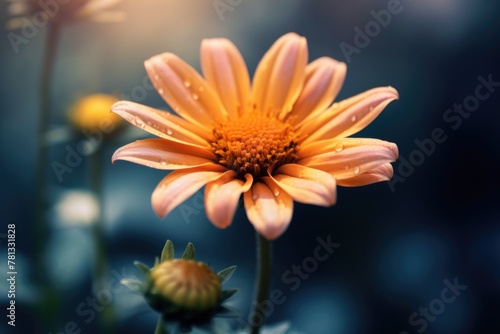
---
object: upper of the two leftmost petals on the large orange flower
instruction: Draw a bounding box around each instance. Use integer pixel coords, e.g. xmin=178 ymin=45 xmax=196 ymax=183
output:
xmin=111 ymin=101 xmax=211 ymax=147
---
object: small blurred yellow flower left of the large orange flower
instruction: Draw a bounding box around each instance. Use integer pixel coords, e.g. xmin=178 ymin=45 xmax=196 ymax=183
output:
xmin=69 ymin=94 xmax=122 ymax=133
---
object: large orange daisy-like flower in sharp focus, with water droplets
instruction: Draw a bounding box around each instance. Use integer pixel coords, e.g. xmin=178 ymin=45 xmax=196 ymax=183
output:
xmin=112 ymin=33 xmax=398 ymax=240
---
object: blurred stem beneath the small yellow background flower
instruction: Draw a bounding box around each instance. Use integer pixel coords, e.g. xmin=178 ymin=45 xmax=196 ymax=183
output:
xmin=89 ymin=148 xmax=115 ymax=334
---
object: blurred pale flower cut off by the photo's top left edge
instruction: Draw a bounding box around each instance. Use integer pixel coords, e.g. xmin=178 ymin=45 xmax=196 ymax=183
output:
xmin=6 ymin=0 xmax=125 ymax=29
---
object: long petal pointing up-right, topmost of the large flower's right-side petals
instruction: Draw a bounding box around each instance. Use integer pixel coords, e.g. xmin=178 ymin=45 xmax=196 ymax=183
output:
xmin=301 ymin=87 xmax=398 ymax=143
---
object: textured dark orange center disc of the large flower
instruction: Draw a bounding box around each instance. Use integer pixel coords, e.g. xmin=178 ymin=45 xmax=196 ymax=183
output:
xmin=212 ymin=111 xmax=298 ymax=179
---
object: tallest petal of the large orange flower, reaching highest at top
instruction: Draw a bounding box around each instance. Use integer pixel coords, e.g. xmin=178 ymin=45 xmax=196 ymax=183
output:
xmin=252 ymin=33 xmax=307 ymax=115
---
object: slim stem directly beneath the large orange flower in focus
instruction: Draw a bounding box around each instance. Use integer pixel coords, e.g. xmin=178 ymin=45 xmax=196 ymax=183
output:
xmin=250 ymin=233 xmax=272 ymax=334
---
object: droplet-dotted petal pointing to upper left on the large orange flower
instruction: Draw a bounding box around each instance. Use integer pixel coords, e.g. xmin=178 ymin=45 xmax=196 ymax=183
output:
xmin=144 ymin=53 xmax=227 ymax=129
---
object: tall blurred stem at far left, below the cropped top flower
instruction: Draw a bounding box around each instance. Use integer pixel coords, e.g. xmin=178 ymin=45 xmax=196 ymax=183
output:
xmin=34 ymin=22 xmax=60 ymax=328
